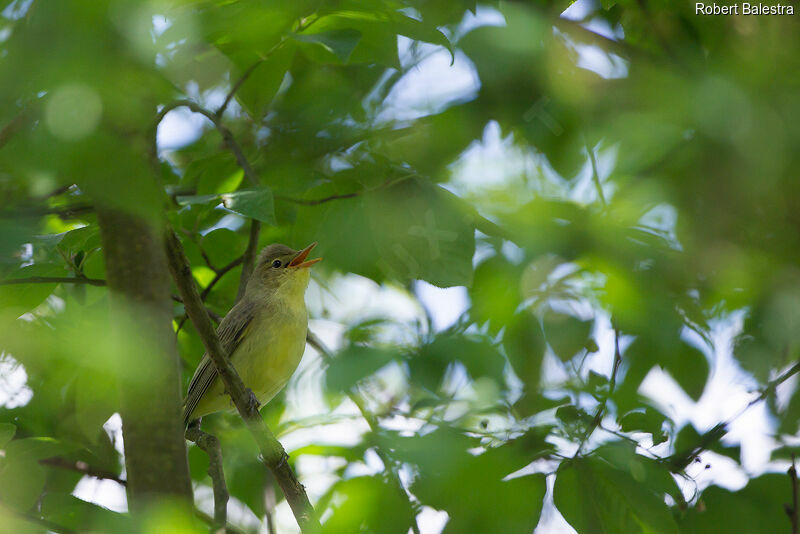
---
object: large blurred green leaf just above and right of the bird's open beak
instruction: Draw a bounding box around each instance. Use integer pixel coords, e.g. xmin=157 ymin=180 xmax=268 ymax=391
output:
xmin=293 ymin=179 xmax=475 ymax=287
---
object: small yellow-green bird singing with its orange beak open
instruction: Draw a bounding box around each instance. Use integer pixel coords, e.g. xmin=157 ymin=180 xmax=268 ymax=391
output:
xmin=183 ymin=242 xmax=322 ymax=427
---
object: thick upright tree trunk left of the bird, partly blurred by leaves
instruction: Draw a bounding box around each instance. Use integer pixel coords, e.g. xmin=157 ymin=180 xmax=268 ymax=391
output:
xmin=98 ymin=210 xmax=192 ymax=513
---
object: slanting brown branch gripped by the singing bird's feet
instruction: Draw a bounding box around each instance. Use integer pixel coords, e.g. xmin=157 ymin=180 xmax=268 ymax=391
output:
xmin=166 ymin=231 xmax=319 ymax=532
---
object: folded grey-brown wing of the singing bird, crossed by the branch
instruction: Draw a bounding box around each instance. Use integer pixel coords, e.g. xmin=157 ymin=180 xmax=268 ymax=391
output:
xmin=183 ymin=300 xmax=255 ymax=426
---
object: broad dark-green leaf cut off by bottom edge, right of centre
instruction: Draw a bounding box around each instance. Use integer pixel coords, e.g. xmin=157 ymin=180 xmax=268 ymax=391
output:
xmin=553 ymin=458 xmax=678 ymax=534
